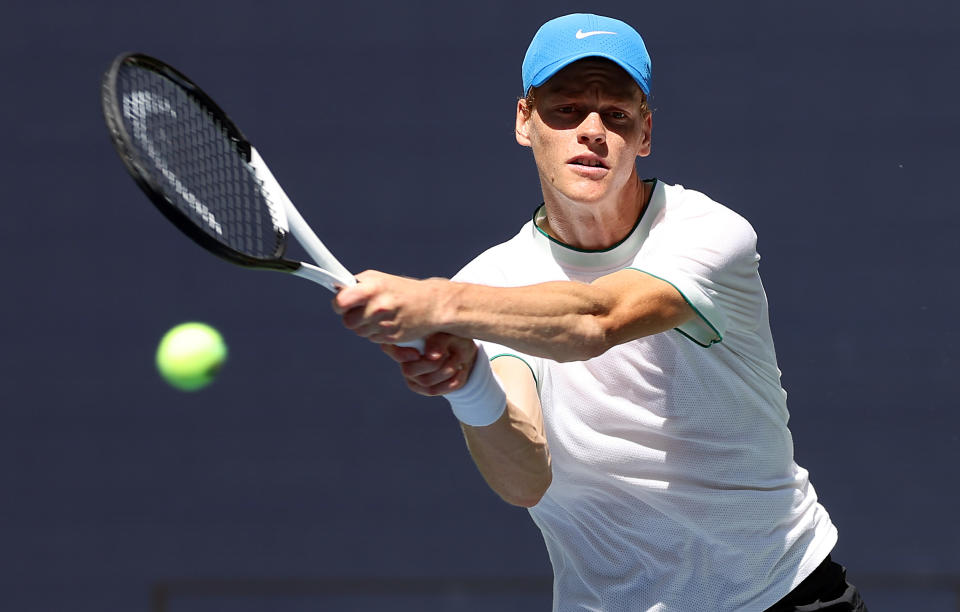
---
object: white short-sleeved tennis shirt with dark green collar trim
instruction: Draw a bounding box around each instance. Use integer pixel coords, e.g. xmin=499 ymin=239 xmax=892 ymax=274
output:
xmin=455 ymin=181 xmax=837 ymax=612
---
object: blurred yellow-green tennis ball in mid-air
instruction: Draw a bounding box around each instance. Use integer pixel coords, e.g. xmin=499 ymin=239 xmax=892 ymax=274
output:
xmin=157 ymin=322 xmax=227 ymax=391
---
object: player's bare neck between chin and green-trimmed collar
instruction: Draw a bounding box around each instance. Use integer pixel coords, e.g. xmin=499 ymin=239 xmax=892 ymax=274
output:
xmin=537 ymin=170 xmax=650 ymax=251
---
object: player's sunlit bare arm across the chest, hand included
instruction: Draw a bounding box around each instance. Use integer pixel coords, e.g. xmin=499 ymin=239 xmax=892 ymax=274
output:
xmin=333 ymin=269 xmax=694 ymax=361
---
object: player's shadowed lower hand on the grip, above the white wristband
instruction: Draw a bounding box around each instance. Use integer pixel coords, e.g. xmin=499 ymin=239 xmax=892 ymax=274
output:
xmin=381 ymin=333 xmax=477 ymax=396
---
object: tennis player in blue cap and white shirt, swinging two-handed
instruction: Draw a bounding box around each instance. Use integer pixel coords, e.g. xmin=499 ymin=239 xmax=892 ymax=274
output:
xmin=334 ymin=14 xmax=866 ymax=612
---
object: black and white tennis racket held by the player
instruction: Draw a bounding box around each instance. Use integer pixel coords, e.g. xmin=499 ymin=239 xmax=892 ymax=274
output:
xmin=100 ymin=53 xmax=423 ymax=351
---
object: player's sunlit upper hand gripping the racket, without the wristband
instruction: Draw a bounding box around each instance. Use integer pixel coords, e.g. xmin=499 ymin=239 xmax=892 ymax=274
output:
xmin=333 ymin=270 xmax=446 ymax=344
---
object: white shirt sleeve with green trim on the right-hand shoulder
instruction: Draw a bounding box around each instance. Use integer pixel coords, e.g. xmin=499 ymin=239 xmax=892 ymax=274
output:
xmin=630 ymin=194 xmax=765 ymax=346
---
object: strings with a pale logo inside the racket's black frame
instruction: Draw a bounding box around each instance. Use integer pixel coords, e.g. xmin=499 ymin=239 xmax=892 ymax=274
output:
xmin=117 ymin=66 xmax=286 ymax=259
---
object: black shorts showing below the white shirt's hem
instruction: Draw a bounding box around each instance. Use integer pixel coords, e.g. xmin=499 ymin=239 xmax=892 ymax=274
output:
xmin=767 ymin=555 xmax=867 ymax=612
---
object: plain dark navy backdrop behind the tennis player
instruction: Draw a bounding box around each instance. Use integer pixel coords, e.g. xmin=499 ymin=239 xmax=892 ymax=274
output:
xmin=0 ymin=0 xmax=960 ymax=611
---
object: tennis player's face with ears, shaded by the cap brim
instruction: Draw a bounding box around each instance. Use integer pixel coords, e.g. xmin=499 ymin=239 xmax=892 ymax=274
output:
xmin=516 ymin=58 xmax=651 ymax=204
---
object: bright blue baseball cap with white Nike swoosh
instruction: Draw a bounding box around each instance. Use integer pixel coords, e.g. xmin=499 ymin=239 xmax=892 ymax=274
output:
xmin=523 ymin=13 xmax=651 ymax=95
